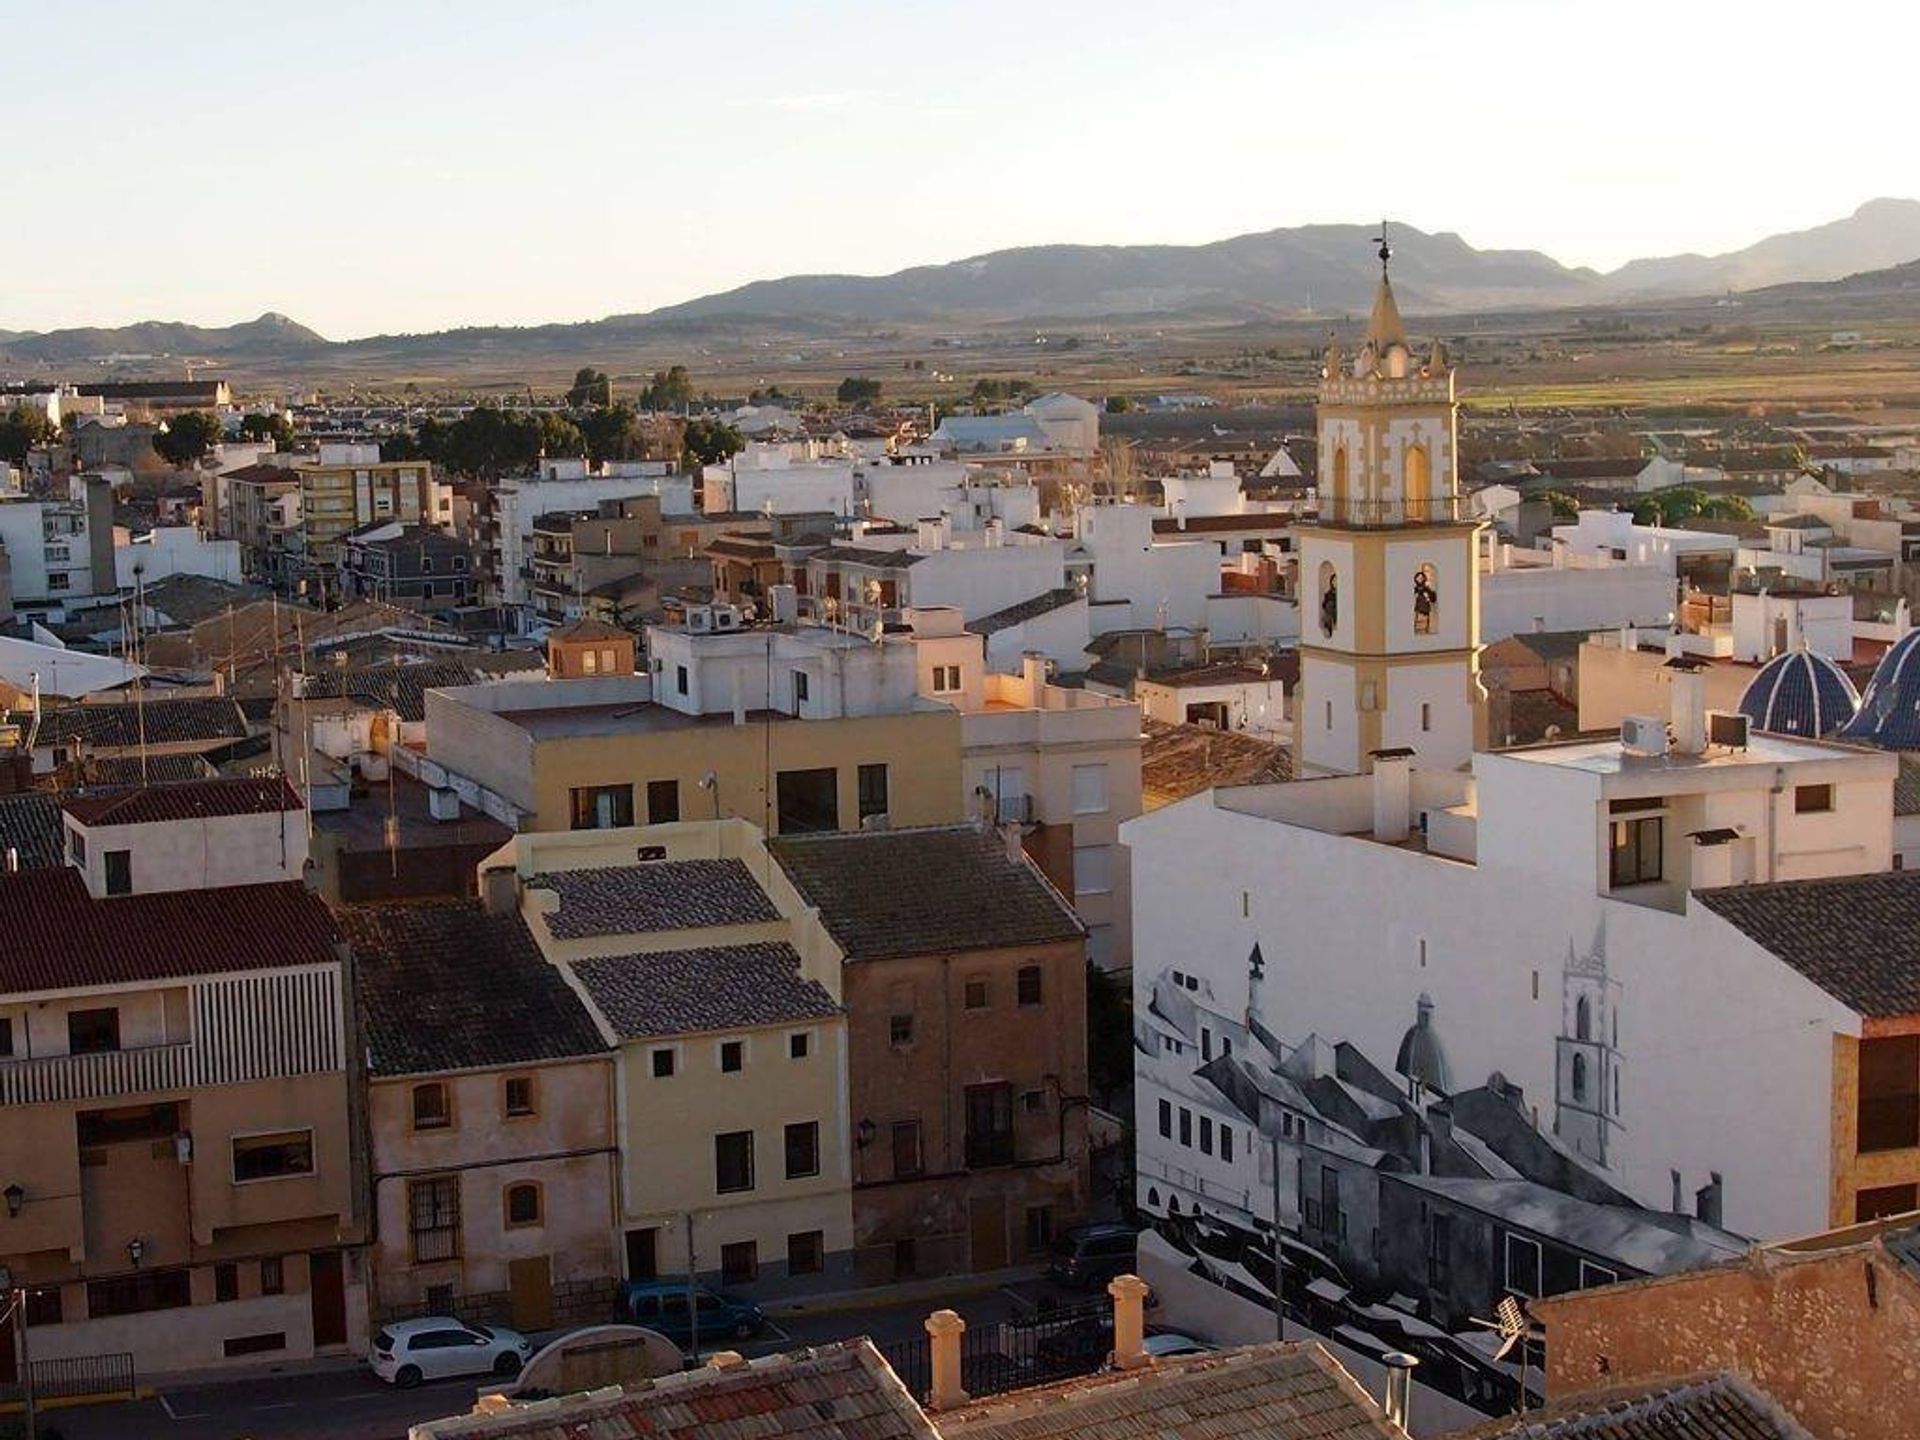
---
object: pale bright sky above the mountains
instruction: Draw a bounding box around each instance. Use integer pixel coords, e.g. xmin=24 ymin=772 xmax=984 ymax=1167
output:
xmin=0 ymin=0 xmax=1920 ymax=340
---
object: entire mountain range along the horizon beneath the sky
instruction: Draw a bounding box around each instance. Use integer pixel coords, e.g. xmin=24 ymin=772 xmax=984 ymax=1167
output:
xmin=0 ymin=200 xmax=1920 ymax=365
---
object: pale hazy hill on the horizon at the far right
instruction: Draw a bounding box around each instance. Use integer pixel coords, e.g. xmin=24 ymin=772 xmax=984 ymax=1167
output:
xmin=1605 ymin=200 xmax=1920 ymax=298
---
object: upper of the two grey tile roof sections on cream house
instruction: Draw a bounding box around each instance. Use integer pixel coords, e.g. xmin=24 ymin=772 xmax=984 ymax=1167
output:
xmin=528 ymin=860 xmax=780 ymax=941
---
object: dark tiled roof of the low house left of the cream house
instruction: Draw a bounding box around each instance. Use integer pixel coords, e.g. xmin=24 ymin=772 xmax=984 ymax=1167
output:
xmin=340 ymin=900 xmax=609 ymax=1075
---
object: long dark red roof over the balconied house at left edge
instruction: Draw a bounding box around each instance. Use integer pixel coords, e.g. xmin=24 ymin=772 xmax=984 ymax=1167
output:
xmin=0 ymin=868 xmax=340 ymax=993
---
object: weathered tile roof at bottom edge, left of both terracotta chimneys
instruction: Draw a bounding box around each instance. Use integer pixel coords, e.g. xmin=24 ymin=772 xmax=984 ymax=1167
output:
xmin=413 ymin=1340 xmax=939 ymax=1440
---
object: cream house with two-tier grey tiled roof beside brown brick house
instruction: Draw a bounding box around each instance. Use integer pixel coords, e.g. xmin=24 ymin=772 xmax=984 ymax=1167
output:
xmin=482 ymin=820 xmax=852 ymax=1292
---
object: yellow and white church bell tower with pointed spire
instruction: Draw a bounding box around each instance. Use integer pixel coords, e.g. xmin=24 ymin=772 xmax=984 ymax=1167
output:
xmin=1294 ymin=227 xmax=1486 ymax=774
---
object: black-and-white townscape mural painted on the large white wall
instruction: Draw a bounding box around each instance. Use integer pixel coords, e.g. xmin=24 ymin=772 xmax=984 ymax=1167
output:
xmin=1135 ymin=924 xmax=1745 ymax=1411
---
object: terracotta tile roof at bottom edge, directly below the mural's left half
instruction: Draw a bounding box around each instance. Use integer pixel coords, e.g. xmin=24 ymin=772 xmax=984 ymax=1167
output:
xmin=935 ymin=1344 xmax=1400 ymax=1440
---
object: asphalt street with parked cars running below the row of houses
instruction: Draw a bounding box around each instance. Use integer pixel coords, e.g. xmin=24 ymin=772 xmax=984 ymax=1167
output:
xmin=40 ymin=1281 xmax=1085 ymax=1440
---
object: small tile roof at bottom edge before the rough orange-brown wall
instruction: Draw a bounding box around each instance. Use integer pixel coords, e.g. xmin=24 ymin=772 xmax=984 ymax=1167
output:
xmin=1453 ymin=1373 xmax=1811 ymax=1440
